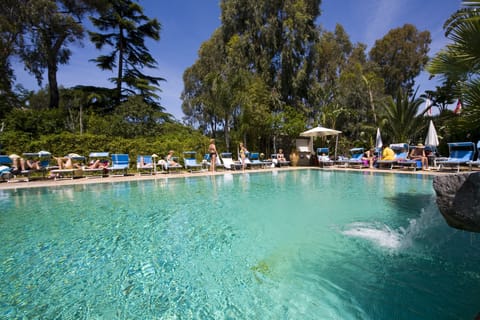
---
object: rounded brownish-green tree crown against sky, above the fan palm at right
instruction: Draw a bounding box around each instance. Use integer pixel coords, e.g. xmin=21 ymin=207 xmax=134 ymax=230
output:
xmin=369 ymin=24 xmax=432 ymax=96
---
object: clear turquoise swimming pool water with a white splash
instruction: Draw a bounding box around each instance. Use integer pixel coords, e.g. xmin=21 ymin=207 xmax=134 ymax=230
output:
xmin=0 ymin=170 xmax=480 ymax=320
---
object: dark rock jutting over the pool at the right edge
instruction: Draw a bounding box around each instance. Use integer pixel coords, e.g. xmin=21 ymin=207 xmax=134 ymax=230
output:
xmin=433 ymin=172 xmax=480 ymax=232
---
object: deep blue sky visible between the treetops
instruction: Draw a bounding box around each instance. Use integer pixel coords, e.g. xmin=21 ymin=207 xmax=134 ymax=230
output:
xmin=15 ymin=0 xmax=461 ymax=120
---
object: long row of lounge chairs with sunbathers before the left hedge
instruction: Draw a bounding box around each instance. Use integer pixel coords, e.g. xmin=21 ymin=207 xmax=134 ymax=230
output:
xmin=0 ymin=151 xmax=289 ymax=182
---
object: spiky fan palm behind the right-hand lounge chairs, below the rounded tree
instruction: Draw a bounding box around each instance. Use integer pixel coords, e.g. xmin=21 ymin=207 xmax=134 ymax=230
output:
xmin=382 ymin=91 xmax=426 ymax=143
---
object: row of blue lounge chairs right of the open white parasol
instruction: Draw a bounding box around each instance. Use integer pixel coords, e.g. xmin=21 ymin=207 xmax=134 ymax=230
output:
xmin=317 ymin=141 xmax=480 ymax=172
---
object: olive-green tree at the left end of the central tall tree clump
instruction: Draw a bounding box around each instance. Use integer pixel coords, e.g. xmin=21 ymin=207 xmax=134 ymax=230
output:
xmin=182 ymin=29 xmax=251 ymax=148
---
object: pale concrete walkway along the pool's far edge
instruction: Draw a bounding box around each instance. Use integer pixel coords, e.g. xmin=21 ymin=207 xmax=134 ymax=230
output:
xmin=0 ymin=166 xmax=456 ymax=190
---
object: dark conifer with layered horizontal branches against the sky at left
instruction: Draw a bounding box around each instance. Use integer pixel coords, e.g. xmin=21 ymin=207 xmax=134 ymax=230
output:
xmin=89 ymin=0 xmax=164 ymax=107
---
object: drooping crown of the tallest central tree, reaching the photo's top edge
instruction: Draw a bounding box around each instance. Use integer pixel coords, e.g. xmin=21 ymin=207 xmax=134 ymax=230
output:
xmin=220 ymin=0 xmax=321 ymax=111
